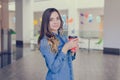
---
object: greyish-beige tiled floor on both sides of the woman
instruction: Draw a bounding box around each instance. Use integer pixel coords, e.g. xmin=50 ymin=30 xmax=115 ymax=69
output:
xmin=0 ymin=48 xmax=120 ymax=80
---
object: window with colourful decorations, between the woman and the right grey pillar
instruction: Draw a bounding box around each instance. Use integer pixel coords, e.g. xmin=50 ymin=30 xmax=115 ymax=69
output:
xmin=78 ymin=8 xmax=104 ymax=50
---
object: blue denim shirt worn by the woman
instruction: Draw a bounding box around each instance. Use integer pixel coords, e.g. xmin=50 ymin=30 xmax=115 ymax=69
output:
xmin=40 ymin=35 xmax=75 ymax=80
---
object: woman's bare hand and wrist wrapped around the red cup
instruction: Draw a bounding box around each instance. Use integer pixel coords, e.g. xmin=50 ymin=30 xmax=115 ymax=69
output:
xmin=62 ymin=38 xmax=79 ymax=54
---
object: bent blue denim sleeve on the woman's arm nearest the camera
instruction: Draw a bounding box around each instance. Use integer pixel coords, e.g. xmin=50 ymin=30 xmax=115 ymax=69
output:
xmin=40 ymin=39 xmax=66 ymax=73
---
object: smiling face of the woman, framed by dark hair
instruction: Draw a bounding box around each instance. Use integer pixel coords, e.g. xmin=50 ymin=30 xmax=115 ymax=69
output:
xmin=49 ymin=12 xmax=61 ymax=33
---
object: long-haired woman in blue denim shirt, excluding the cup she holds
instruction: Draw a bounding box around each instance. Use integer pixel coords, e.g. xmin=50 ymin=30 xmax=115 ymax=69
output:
xmin=39 ymin=8 xmax=78 ymax=80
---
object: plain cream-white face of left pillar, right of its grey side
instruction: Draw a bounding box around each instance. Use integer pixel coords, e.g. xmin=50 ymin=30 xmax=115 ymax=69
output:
xmin=23 ymin=0 xmax=34 ymax=43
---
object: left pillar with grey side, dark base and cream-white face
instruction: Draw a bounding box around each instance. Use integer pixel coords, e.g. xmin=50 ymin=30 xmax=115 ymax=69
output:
xmin=15 ymin=0 xmax=34 ymax=47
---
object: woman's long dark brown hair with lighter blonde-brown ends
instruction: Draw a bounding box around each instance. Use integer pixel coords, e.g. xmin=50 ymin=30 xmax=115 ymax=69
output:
xmin=38 ymin=8 xmax=63 ymax=53
